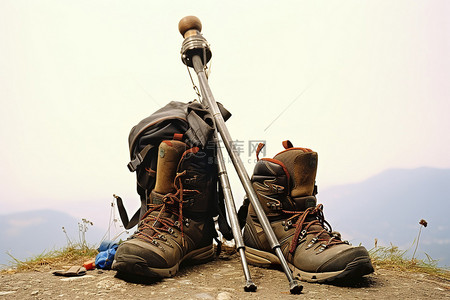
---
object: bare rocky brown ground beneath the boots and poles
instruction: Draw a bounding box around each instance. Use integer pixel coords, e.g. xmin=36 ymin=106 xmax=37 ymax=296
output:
xmin=0 ymin=254 xmax=450 ymax=300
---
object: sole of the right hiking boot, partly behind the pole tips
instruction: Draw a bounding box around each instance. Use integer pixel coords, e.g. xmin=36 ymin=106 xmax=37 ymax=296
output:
xmin=245 ymin=247 xmax=374 ymax=283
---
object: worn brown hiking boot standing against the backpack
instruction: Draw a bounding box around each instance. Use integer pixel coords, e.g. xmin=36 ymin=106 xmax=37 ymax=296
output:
xmin=112 ymin=140 xmax=216 ymax=278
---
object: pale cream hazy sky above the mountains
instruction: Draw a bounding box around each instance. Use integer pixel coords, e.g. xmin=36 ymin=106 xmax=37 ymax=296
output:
xmin=0 ymin=0 xmax=450 ymax=227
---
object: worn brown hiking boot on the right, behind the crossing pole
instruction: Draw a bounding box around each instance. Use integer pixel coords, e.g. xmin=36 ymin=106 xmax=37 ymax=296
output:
xmin=244 ymin=141 xmax=373 ymax=282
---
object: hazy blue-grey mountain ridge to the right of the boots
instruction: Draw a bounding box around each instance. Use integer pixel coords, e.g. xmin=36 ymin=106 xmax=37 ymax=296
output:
xmin=318 ymin=167 xmax=450 ymax=267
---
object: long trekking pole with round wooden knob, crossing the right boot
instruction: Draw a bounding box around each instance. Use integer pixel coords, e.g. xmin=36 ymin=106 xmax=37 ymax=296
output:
xmin=178 ymin=16 xmax=303 ymax=294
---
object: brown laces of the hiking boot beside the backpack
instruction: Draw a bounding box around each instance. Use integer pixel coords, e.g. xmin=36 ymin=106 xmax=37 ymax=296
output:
xmin=136 ymin=171 xmax=200 ymax=246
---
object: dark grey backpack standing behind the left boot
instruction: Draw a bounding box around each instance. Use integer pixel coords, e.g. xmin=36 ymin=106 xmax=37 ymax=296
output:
xmin=115 ymin=101 xmax=233 ymax=240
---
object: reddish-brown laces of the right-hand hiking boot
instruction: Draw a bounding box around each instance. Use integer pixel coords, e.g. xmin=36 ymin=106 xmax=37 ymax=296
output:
xmin=283 ymin=204 xmax=348 ymax=254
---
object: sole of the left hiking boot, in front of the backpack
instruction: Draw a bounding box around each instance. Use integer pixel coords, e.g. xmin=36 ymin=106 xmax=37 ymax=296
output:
xmin=112 ymin=245 xmax=214 ymax=278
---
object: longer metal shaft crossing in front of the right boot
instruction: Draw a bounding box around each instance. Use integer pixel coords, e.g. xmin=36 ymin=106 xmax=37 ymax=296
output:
xmin=192 ymin=55 xmax=302 ymax=293
